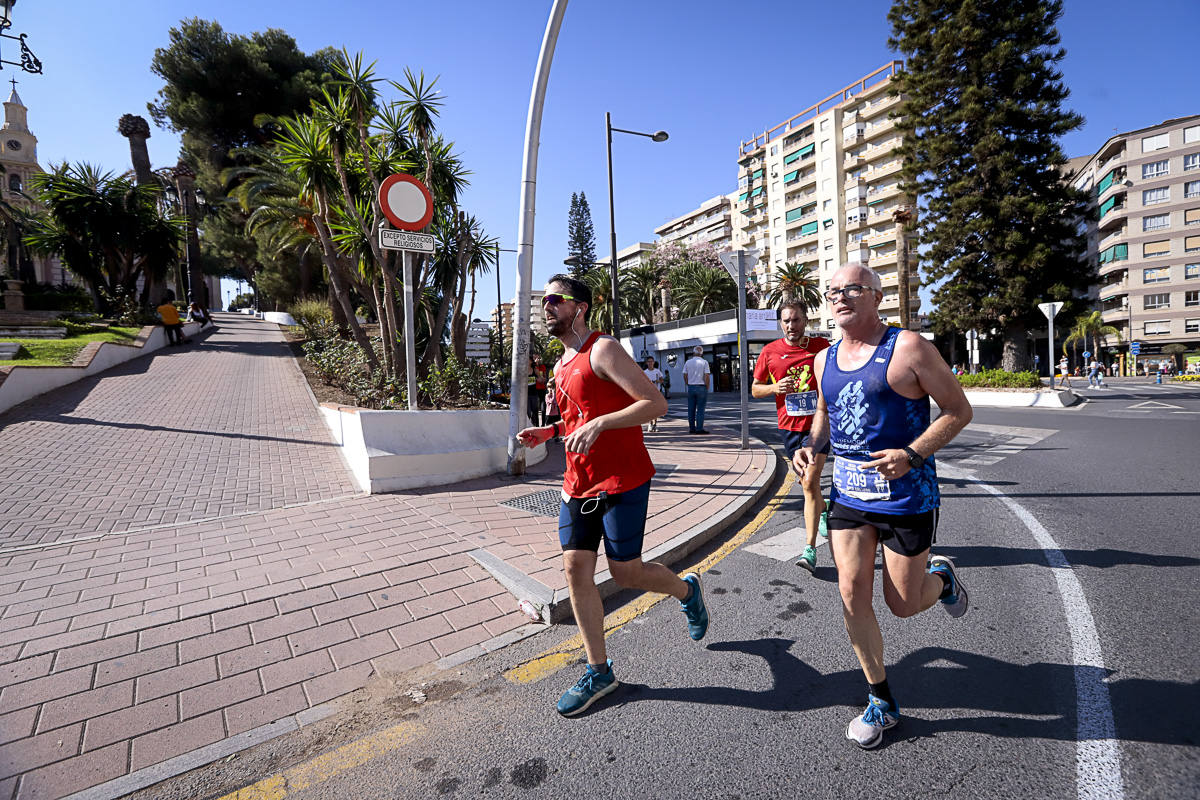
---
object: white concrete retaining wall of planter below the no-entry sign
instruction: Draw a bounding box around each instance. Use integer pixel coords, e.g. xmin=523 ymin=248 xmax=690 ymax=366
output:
xmin=320 ymin=403 xmax=546 ymax=494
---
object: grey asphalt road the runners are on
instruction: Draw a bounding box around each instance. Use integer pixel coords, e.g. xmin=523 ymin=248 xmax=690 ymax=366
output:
xmin=139 ymin=381 xmax=1200 ymax=800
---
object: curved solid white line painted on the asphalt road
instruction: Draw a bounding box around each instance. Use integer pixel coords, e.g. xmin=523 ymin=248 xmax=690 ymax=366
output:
xmin=953 ymin=470 xmax=1124 ymax=800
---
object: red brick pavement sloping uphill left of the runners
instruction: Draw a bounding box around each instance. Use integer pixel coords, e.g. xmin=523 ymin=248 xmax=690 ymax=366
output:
xmin=0 ymin=320 xmax=774 ymax=800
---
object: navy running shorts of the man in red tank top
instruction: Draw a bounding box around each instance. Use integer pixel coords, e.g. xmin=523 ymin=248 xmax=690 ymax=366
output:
xmin=558 ymin=481 xmax=650 ymax=561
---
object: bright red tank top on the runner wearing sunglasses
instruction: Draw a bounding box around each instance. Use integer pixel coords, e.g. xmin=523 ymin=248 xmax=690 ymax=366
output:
xmin=554 ymin=331 xmax=654 ymax=498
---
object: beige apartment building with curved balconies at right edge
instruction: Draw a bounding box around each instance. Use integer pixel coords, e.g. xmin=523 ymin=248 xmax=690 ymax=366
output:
xmin=1070 ymin=115 xmax=1200 ymax=355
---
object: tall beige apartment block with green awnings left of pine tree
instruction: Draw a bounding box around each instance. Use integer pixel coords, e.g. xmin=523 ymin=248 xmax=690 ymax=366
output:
xmin=732 ymin=61 xmax=920 ymax=330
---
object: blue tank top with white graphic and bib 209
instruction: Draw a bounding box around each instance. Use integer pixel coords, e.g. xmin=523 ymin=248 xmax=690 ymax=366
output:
xmin=821 ymin=326 xmax=941 ymax=515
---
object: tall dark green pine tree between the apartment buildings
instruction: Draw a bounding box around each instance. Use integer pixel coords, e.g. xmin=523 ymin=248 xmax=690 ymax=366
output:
xmin=888 ymin=0 xmax=1093 ymax=369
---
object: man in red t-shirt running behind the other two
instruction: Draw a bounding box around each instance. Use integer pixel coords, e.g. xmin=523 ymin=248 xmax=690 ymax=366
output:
xmin=750 ymin=300 xmax=829 ymax=572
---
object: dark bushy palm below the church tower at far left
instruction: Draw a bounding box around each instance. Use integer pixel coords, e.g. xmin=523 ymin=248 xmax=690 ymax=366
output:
xmin=23 ymin=163 xmax=182 ymax=312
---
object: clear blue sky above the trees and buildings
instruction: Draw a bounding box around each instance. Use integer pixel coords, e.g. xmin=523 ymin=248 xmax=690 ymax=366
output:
xmin=16 ymin=0 xmax=1200 ymax=317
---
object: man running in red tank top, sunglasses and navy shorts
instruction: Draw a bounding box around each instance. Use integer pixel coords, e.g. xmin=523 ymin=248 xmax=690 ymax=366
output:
xmin=517 ymin=275 xmax=708 ymax=716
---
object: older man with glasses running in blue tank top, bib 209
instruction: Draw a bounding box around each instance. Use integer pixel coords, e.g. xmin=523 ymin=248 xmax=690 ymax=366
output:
xmin=793 ymin=264 xmax=971 ymax=747
